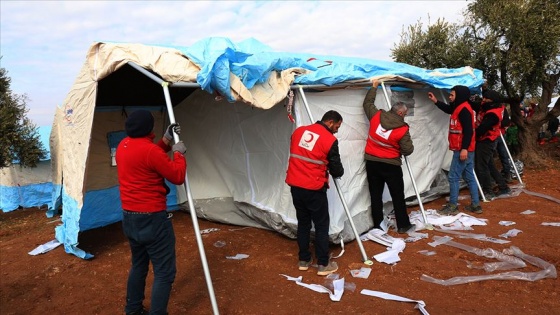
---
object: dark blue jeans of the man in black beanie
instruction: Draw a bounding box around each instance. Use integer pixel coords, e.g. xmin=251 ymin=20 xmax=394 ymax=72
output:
xmin=122 ymin=211 xmax=177 ymax=314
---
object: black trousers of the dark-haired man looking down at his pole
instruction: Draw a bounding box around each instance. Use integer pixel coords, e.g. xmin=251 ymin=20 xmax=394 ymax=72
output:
xmin=291 ymin=186 xmax=330 ymax=266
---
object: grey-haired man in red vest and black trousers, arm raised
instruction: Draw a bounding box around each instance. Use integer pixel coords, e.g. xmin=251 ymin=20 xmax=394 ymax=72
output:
xmin=363 ymin=80 xmax=416 ymax=233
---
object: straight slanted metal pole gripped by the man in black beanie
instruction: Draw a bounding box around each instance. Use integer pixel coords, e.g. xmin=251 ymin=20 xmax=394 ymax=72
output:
xmin=162 ymin=82 xmax=219 ymax=315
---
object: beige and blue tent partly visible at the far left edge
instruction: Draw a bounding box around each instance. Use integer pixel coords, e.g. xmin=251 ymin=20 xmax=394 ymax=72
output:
xmin=0 ymin=126 xmax=53 ymax=212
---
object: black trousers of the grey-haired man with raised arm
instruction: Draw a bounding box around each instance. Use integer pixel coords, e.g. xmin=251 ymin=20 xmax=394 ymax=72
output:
xmin=366 ymin=160 xmax=410 ymax=228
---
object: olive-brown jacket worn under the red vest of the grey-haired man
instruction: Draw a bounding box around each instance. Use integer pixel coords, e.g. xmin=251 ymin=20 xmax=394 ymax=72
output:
xmin=363 ymin=88 xmax=414 ymax=165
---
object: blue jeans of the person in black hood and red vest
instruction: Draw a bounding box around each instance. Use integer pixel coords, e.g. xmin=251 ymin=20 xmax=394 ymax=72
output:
xmin=447 ymin=151 xmax=480 ymax=206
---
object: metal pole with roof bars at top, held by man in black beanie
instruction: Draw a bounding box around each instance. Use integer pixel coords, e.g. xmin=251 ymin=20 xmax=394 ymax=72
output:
xmin=128 ymin=61 xmax=219 ymax=315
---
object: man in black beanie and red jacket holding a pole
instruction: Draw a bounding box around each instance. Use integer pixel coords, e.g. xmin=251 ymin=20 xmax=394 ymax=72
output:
xmin=116 ymin=110 xmax=187 ymax=315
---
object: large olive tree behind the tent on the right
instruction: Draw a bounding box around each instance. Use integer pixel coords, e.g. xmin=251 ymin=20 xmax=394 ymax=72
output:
xmin=392 ymin=0 xmax=560 ymax=164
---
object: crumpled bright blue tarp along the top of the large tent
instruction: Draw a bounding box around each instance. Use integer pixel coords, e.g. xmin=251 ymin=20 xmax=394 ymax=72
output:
xmin=174 ymin=37 xmax=484 ymax=101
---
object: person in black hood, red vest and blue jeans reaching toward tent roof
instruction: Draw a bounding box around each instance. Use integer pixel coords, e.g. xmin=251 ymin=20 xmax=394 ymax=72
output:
xmin=428 ymin=85 xmax=482 ymax=215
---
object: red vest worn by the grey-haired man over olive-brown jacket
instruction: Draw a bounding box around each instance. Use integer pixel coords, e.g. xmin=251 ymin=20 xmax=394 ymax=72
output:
xmin=366 ymin=111 xmax=408 ymax=159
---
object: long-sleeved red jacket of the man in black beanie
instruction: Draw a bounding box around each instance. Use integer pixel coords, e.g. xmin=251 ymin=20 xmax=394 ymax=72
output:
xmin=116 ymin=133 xmax=187 ymax=212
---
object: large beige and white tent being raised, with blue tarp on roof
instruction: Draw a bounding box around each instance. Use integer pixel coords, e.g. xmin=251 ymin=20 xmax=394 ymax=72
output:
xmin=50 ymin=38 xmax=483 ymax=258
